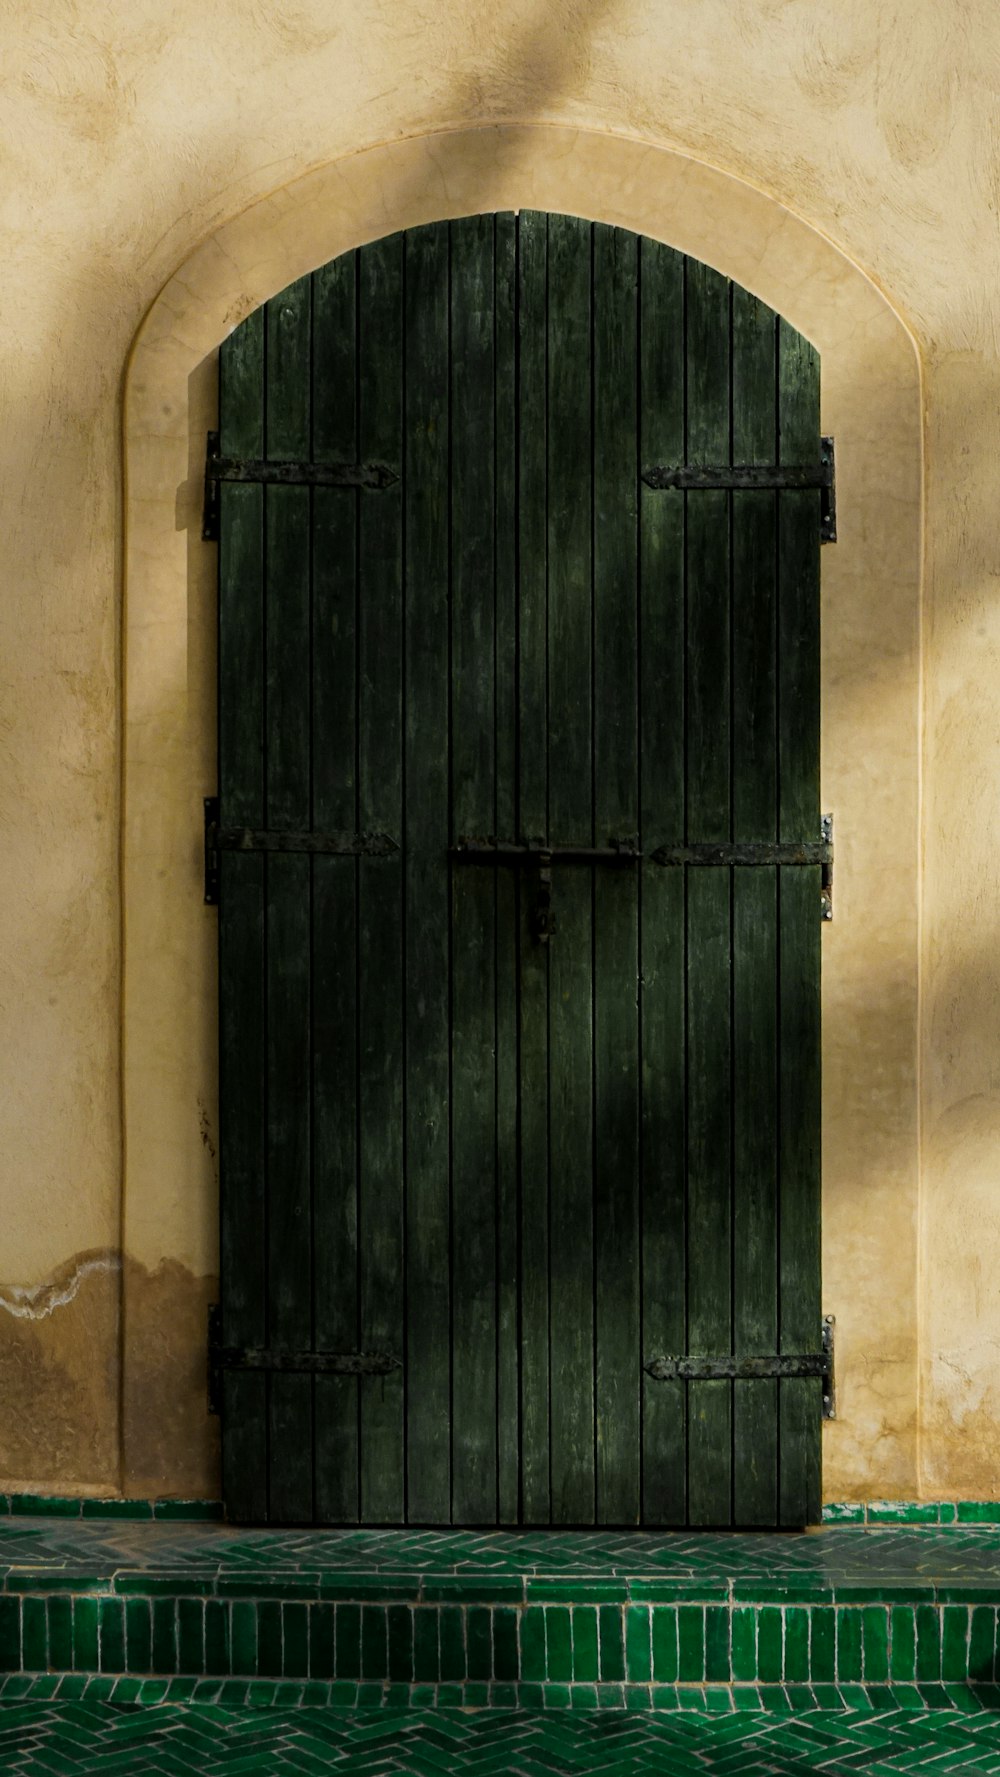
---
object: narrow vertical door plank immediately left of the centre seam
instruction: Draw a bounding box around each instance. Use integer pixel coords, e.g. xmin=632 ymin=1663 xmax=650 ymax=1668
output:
xmin=494 ymin=213 xmax=520 ymax=1525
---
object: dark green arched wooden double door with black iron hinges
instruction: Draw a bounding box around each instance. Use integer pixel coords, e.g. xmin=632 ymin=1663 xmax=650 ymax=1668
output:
xmin=218 ymin=211 xmax=821 ymax=1525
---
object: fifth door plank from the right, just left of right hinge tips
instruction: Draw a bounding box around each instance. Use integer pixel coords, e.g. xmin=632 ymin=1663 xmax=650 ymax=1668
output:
xmin=593 ymin=226 xmax=641 ymax=1525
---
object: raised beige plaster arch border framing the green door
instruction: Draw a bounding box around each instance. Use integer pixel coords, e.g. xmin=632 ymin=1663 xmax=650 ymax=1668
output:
xmin=123 ymin=124 xmax=922 ymax=1498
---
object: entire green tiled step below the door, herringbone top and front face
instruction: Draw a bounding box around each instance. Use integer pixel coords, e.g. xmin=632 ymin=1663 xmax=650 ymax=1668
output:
xmin=0 ymin=1514 xmax=1000 ymax=1708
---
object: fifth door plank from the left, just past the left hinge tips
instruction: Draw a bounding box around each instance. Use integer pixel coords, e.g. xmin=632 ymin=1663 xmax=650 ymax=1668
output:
xmin=403 ymin=224 xmax=451 ymax=1523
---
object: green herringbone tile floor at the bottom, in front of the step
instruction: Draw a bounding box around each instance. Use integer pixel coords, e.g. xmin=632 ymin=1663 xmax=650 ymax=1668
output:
xmin=0 ymin=1702 xmax=1000 ymax=1777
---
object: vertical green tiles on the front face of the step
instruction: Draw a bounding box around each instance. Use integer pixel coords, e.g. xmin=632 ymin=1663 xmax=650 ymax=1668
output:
xmin=0 ymin=1599 xmax=1000 ymax=1686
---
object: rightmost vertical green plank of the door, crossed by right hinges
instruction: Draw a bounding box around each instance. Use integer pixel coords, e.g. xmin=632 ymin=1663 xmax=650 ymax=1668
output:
xmin=778 ymin=322 xmax=821 ymax=1525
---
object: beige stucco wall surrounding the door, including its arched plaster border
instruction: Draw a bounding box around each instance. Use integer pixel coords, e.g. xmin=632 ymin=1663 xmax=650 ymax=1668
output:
xmin=0 ymin=0 xmax=1000 ymax=1498
